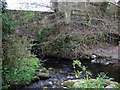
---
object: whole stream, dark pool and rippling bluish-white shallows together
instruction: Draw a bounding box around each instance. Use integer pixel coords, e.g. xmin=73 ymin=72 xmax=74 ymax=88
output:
xmin=24 ymin=58 xmax=120 ymax=88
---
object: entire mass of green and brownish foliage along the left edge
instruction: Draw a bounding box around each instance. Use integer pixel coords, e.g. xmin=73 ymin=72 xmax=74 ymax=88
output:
xmin=2 ymin=6 xmax=41 ymax=88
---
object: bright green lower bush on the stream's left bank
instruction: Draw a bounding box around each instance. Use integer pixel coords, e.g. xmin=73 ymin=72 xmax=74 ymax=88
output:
xmin=3 ymin=58 xmax=39 ymax=84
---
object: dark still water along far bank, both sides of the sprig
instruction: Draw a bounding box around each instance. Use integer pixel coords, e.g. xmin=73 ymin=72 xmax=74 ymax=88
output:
xmin=44 ymin=58 xmax=120 ymax=82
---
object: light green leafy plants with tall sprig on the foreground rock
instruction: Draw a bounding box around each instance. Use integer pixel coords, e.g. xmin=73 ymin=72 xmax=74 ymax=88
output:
xmin=73 ymin=60 xmax=119 ymax=88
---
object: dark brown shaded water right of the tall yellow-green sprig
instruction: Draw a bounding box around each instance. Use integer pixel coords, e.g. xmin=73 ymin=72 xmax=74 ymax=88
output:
xmin=79 ymin=61 xmax=120 ymax=83
